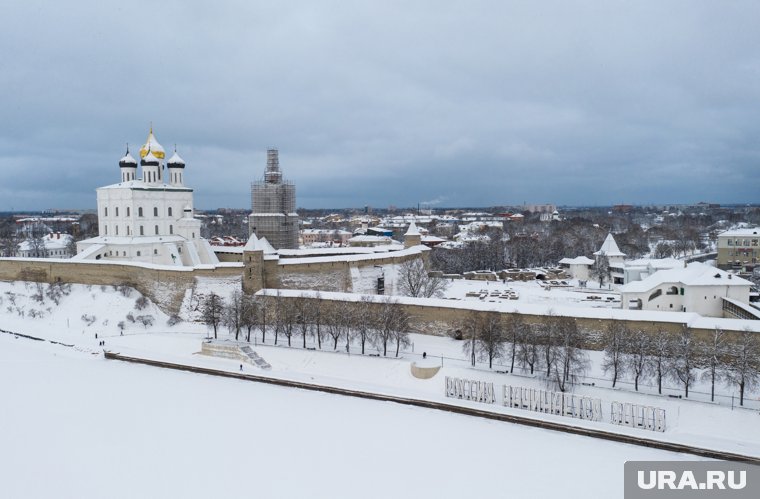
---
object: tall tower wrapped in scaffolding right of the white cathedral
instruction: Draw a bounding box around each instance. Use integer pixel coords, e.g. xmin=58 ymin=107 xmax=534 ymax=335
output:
xmin=248 ymin=149 xmax=298 ymax=249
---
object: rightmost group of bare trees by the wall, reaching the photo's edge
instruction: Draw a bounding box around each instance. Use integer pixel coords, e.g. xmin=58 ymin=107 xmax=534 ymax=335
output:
xmin=602 ymin=321 xmax=760 ymax=405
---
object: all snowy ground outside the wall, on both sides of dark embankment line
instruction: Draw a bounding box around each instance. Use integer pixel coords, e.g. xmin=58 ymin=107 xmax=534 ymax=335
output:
xmin=0 ymin=283 xmax=760 ymax=497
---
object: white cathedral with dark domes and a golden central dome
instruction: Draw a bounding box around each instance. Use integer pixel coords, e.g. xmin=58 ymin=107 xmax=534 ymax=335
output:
xmin=74 ymin=131 xmax=219 ymax=267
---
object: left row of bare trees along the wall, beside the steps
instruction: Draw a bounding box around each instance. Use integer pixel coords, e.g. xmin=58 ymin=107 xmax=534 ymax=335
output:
xmin=201 ymin=291 xmax=410 ymax=357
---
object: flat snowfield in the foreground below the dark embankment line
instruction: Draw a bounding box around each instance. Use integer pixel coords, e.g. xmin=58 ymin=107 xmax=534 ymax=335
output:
xmin=0 ymin=335 xmax=694 ymax=499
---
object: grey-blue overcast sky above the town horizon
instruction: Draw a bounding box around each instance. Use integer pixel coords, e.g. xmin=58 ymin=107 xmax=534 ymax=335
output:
xmin=0 ymin=0 xmax=760 ymax=211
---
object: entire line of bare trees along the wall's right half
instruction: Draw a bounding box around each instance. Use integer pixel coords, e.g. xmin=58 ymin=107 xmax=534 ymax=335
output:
xmin=457 ymin=311 xmax=760 ymax=405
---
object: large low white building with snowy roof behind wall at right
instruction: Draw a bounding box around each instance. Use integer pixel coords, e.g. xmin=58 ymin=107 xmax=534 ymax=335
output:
xmin=620 ymin=263 xmax=760 ymax=319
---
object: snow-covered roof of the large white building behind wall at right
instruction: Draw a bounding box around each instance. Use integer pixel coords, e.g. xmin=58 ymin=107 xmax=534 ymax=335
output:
xmin=620 ymin=262 xmax=752 ymax=293
